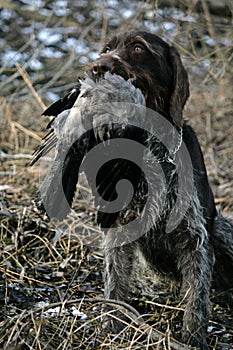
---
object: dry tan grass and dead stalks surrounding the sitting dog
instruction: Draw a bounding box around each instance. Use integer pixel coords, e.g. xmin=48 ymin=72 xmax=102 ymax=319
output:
xmin=0 ymin=1 xmax=233 ymax=350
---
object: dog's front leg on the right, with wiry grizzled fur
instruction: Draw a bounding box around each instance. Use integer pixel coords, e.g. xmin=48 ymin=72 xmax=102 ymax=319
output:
xmin=179 ymin=243 xmax=214 ymax=350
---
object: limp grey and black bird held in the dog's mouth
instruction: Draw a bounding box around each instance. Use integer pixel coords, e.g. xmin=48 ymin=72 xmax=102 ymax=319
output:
xmin=31 ymin=72 xmax=145 ymax=228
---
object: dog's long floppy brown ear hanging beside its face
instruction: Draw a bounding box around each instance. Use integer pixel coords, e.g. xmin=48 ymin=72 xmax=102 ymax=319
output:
xmin=169 ymin=46 xmax=189 ymax=127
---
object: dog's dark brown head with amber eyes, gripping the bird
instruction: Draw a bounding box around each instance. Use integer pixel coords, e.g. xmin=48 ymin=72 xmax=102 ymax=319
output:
xmin=90 ymin=32 xmax=189 ymax=126
